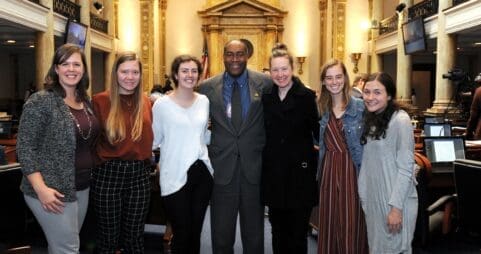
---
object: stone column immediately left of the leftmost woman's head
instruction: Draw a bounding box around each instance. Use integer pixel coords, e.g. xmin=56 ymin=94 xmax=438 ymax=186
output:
xmin=35 ymin=0 xmax=55 ymax=90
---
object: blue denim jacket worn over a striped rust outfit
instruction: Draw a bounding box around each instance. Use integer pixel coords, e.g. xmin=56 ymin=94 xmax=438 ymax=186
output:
xmin=317 ymin=96 xmax=364 ymax=180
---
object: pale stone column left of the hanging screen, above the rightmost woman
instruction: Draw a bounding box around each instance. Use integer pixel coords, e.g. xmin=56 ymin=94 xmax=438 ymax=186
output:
xmin=396 ymin=0 xmax=412 ymax=104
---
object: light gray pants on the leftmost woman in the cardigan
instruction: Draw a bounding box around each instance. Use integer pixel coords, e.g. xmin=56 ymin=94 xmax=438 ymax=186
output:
xmin=23 ymin=189 xmax=89 ymax=254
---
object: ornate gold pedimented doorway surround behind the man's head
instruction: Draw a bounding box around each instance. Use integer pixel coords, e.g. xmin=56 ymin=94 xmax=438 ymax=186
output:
xmin=198 ymin=0 xmax=287 ymax=75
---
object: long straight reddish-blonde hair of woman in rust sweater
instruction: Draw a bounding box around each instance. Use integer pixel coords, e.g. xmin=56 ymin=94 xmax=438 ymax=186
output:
xmin=105 ymin=52 xmax=144 ymax=144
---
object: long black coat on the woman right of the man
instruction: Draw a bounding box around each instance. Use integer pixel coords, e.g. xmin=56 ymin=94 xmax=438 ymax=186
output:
xmin=262 ymin=77 xmax=319 ymax=209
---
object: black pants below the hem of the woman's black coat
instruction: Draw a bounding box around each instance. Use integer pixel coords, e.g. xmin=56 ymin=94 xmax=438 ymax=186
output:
xmin=269 ymin=207 xmax=312 ymax=254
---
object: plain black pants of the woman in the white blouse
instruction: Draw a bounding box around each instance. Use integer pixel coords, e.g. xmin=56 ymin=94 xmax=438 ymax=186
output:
xmin=162 ymin=160 xmax=213 ymax=254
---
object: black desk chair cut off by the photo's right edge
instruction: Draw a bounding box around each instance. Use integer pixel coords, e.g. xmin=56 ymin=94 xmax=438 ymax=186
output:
xmin=454 ymin=160 xmax=481 ymax=236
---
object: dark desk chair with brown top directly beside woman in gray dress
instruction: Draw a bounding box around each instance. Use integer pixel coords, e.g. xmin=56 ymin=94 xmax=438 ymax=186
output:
xmin=414 ymin=152 xmax=455 ymax=247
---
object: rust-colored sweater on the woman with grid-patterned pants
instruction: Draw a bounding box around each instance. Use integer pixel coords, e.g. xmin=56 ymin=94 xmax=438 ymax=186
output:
xmin=92 ymin=91 xmax=153 ymax=163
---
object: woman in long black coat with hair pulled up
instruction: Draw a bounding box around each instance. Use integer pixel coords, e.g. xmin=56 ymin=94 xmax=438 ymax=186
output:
xmin=262 ymin=44 xmax=319 ymax=254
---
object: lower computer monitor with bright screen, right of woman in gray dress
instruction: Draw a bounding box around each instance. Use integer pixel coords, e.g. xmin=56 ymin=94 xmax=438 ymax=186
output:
xmin=424 ymin=136 xmax=465 ymax=163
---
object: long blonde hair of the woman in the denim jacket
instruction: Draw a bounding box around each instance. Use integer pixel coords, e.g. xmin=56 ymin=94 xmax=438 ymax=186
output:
xmin=317 ymin=59 xmax=351 ymax=116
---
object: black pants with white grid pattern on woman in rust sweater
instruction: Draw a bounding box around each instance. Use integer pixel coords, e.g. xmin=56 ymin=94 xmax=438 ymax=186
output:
xmin=91 ymin=160 xmax=150 ymax=254
